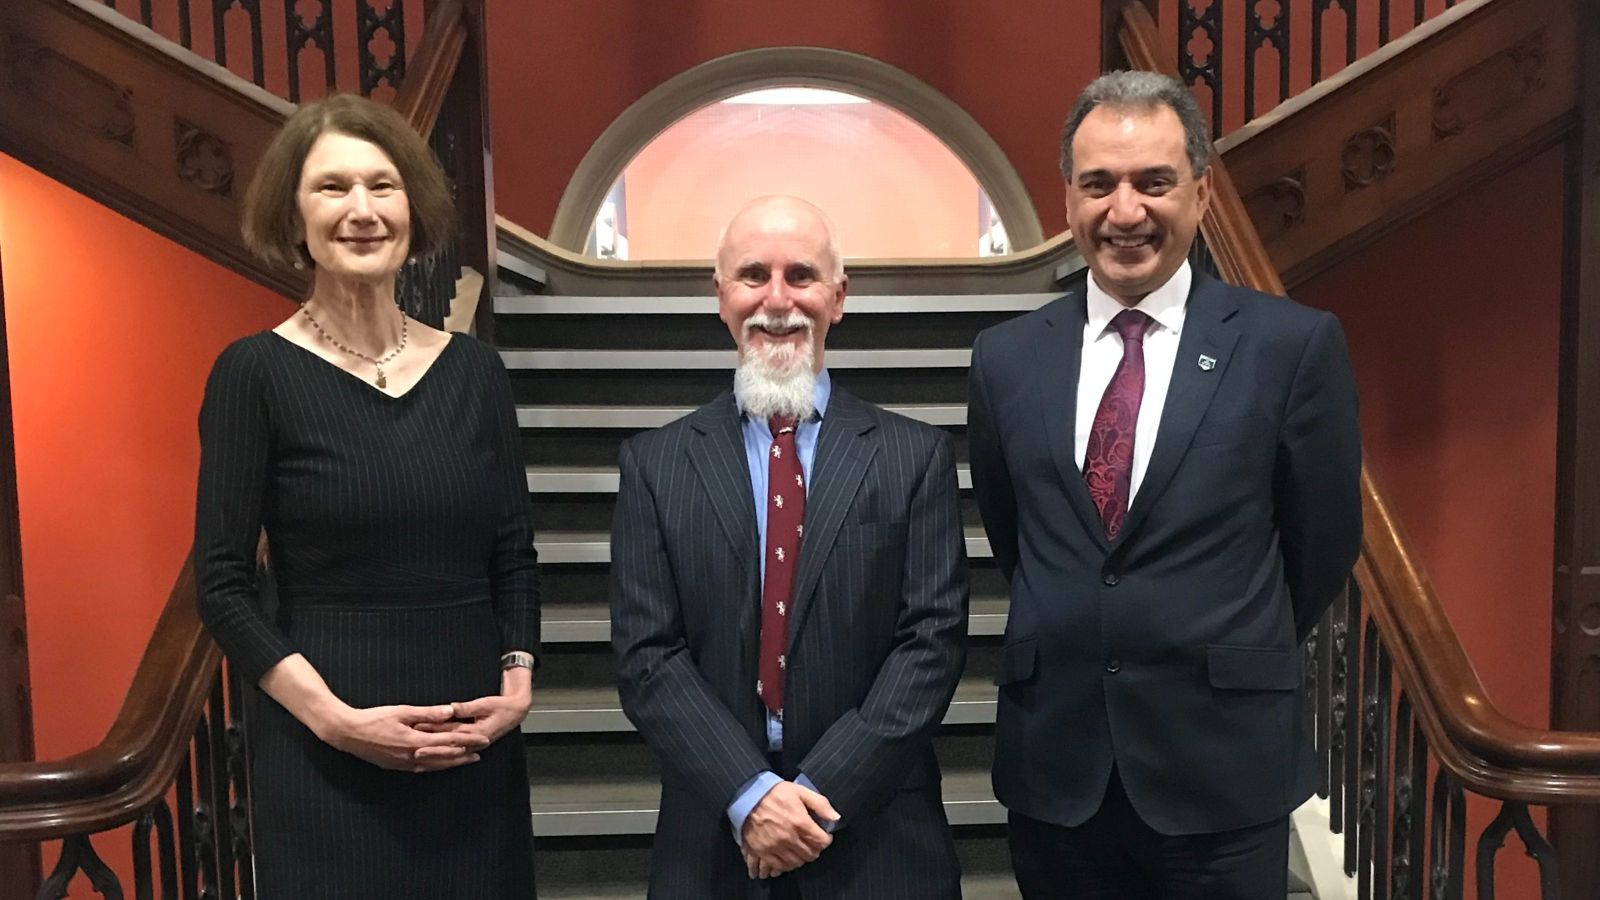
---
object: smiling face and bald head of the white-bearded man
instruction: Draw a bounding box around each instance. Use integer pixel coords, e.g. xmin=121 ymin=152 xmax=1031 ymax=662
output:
xmin=714 ymin=197 xmax=848 ymax=372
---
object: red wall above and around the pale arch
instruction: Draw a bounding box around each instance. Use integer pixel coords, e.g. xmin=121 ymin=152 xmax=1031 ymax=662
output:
xmin=486 ymin=0 xmax=1099 ymax=240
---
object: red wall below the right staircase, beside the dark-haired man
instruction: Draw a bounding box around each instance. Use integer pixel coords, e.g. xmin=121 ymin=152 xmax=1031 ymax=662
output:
xmin=1296 ymin=149 xmax=1562 ymax=900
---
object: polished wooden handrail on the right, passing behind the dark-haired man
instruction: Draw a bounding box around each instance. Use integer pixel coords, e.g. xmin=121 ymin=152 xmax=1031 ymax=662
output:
xmin=1118 ymin=0 xmax=1600 ymax=804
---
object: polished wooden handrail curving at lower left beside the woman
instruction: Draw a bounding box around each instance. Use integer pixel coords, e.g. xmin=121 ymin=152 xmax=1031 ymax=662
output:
xmin=0 ymin=560 xmax=222 ymax=841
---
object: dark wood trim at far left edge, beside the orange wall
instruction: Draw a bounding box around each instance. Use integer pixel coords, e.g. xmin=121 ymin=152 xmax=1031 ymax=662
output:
xmin=0 ymin=238 xmax=40 ymax=900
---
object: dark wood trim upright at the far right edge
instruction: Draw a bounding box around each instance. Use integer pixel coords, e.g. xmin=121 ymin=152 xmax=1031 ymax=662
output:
xmin=1550 ymin=0 xmax=1600 ymax=883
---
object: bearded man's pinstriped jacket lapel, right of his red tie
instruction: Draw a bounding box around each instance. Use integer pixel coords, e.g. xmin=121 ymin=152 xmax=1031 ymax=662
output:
xmin=789 ymin=386 xmax=878 ymax=649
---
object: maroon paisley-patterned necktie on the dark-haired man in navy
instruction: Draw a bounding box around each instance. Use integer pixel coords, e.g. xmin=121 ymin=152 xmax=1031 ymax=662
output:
xmin=1083 ymin=309 xmax=1150 ymax=541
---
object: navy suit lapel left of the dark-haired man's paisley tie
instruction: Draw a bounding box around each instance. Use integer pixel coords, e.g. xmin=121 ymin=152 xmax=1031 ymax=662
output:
xmin=1035 ymin=288 xmax=1109 ymax=548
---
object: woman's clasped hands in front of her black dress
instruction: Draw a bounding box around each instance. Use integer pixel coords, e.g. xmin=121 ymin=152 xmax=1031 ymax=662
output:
xmin=314 ymin=706 xmax=490 ymax=772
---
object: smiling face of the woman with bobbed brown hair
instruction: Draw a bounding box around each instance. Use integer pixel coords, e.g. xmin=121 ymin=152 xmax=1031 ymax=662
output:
xmin=296 ymin=131 xmax=411 ymax=283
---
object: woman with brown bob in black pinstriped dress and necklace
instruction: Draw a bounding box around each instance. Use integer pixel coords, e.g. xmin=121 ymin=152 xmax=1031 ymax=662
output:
xmin=195 ymin=96 xmax=539 ymax=900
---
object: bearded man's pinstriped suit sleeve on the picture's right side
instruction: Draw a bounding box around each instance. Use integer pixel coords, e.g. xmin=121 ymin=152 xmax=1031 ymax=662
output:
xmin=800 ymin=434 xmax=968 ymax=826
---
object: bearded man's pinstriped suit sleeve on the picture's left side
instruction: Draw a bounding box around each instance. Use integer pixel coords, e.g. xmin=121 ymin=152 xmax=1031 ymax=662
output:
xmin=611 ymin=442 xmax=768 ymax=810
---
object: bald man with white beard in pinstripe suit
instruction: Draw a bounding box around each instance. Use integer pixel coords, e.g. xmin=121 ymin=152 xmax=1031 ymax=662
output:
xmin=611 ymin=197 xmax=968 ymax=900
